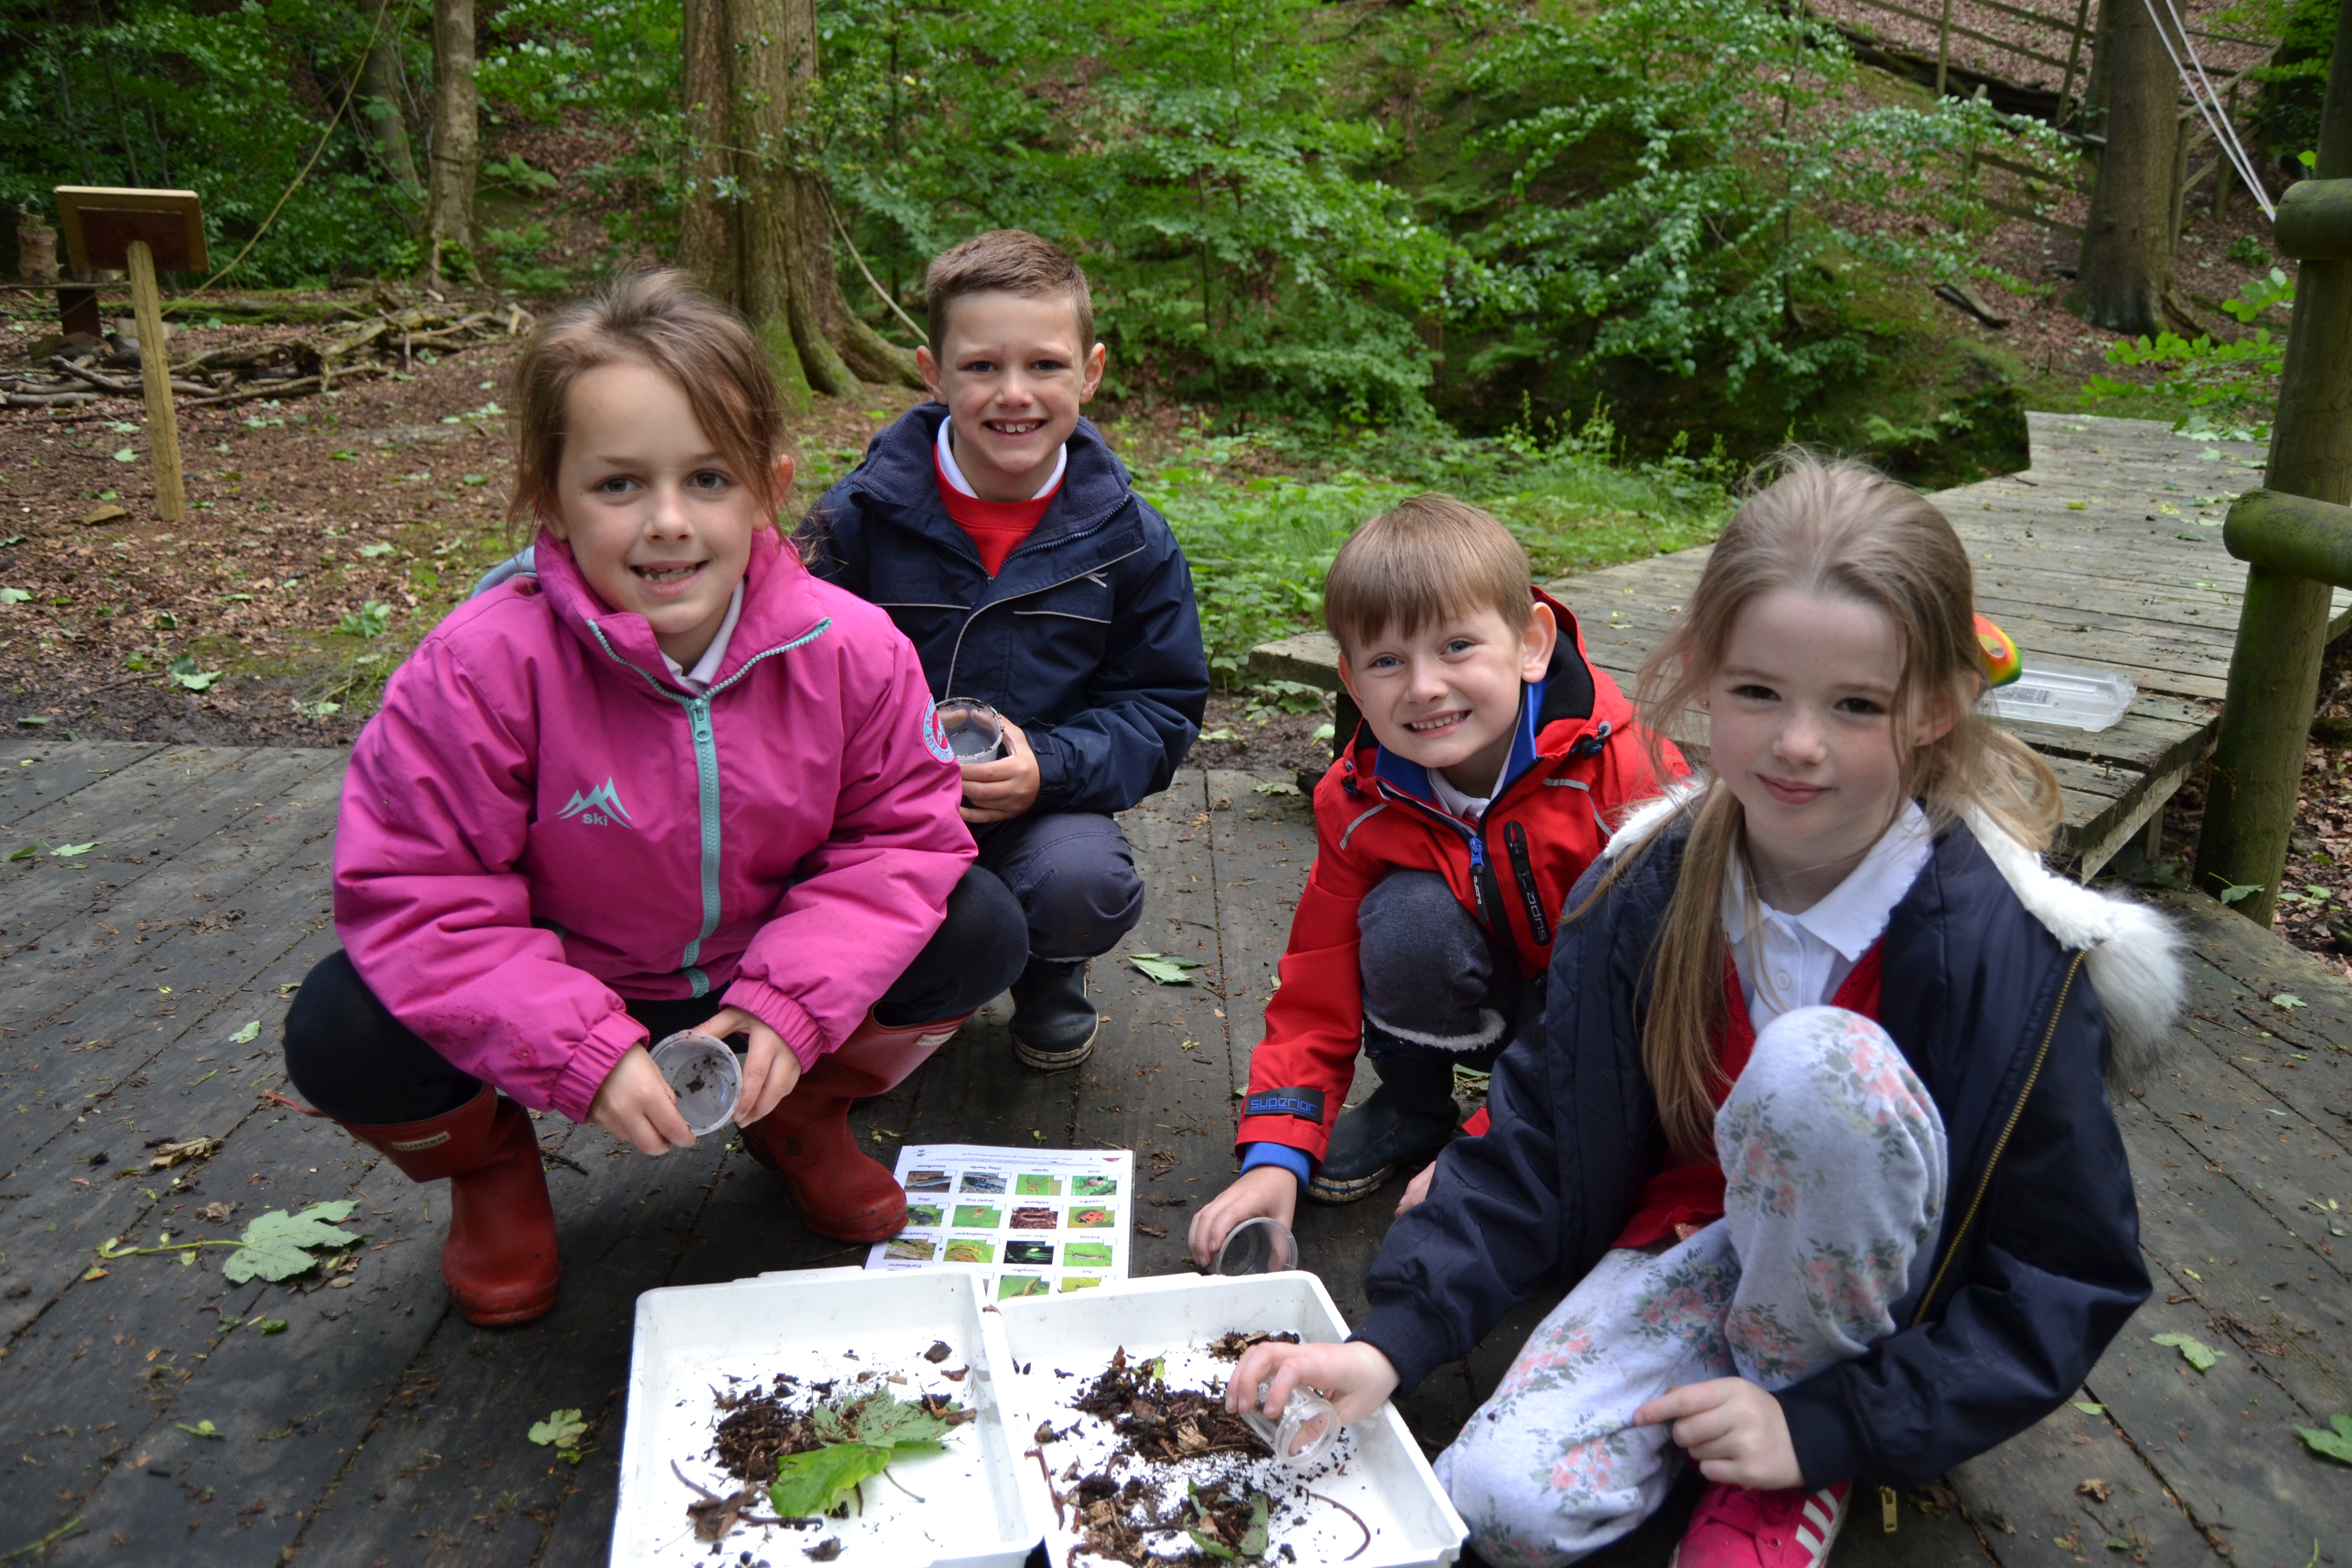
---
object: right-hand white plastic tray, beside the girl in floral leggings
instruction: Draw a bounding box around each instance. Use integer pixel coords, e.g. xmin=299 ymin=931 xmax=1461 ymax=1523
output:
xmin=981 ymin=1272 xmax=1467 ymax=1568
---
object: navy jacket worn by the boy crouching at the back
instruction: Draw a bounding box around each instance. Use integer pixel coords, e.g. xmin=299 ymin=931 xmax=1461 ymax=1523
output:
xmin=800 ymin=402 xmax=1209 ymax=814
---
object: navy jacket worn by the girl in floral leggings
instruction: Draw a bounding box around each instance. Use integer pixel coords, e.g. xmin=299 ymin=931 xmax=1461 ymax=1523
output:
xmin=1355 ymin=825 xmax=2147 ymax=1486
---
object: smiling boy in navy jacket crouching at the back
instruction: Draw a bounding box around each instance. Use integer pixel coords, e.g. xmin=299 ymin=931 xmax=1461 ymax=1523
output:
xmin=802 ymin=230 xmax=1209 ymax=1070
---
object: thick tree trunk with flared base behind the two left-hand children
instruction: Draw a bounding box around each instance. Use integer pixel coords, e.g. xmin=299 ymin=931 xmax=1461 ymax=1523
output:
xmin=677 ymin=0 xmax=922 ymax=397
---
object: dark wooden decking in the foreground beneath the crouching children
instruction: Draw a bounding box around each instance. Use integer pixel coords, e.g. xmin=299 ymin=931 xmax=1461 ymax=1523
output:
xmin=0 ymin=736 xmax=2352 ymax=1568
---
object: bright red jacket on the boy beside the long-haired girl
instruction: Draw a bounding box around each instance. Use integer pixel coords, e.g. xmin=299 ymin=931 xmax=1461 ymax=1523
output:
xmin=1237 ymin=587 xmax=1686 ymax=1161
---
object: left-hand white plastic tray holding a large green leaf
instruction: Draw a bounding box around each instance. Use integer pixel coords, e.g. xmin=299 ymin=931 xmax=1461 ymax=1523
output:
xmin=611 ymin=1269 xmax=1054 ymax=1568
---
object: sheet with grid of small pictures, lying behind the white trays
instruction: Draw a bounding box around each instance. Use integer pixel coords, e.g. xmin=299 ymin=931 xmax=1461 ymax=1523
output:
xmin=866 ymin=1142 xmax=1136 ymax=1300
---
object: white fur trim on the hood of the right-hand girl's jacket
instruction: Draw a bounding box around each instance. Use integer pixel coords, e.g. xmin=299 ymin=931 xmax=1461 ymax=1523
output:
xmin=1602 ymin=778 xmax=2187 ymax=1088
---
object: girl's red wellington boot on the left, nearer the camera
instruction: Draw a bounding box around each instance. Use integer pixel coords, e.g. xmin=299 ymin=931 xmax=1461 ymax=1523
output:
xmin=341 ymin=1084 xmax=562 ymax=1328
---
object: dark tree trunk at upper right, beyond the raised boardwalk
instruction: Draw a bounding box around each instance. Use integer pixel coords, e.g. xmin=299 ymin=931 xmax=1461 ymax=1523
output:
xmin=2067 ymin=0 xmax=2197 ymax=336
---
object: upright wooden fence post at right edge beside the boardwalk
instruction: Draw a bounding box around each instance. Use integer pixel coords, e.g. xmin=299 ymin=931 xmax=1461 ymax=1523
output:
xmin=2197 ymin=5 xmax=2352 ymax=926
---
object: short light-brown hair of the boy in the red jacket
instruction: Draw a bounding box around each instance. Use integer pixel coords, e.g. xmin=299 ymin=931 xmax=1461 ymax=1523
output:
xmin=1324 ymin=496 xmax=1536 ymax=653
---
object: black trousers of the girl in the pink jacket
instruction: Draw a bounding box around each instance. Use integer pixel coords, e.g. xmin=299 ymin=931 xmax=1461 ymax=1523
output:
xmin=287 ymin=868 xmax=1028 ymax=1126
